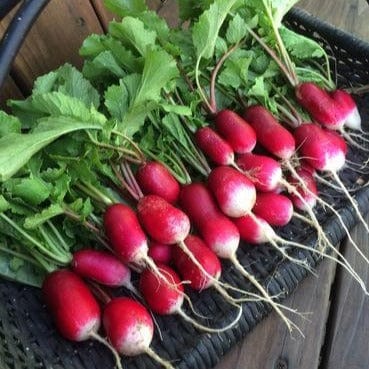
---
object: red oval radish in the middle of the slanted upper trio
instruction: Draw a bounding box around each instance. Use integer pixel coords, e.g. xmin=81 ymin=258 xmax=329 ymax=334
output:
xmin=214 ymin=110 xmax=256 ymax=154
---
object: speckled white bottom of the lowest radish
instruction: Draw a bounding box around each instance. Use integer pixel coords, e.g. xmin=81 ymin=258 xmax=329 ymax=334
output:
xmin=118 ymin=324 xmax=153 ymax=356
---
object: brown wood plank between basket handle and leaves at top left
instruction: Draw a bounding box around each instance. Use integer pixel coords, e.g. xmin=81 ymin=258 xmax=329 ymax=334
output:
xmin=1 ymin=0 xmax=102 ymax=93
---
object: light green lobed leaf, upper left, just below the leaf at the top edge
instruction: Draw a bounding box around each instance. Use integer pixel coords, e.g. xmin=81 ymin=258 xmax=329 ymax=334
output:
xmin=109 ymin=16 xmax=156 ymax=57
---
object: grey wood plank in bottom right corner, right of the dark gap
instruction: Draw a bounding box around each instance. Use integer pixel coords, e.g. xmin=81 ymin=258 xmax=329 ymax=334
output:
xmin=323 ymin=216 xmax=369 ymax=369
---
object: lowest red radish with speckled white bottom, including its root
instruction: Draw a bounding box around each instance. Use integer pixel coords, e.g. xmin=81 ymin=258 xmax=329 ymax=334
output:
xmin=103 ymin=296 xmax=174 ymax=369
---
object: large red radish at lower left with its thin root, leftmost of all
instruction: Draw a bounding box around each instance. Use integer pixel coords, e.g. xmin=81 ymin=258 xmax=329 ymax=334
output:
xmin=42 ymin=269 xmax=122 ymax=369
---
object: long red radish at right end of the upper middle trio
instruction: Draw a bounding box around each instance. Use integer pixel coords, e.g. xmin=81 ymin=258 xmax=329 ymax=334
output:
xmin=243 ymin=105 xmax=296 ymax=160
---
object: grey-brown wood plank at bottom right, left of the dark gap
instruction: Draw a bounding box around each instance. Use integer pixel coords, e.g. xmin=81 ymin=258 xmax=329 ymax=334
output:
xmin=215 ymin=261 xmax=336 ymax=369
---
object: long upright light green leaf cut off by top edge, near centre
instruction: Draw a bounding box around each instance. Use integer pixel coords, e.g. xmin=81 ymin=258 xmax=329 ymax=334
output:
xmin=192 ymin=0 xmax=237 ymax=59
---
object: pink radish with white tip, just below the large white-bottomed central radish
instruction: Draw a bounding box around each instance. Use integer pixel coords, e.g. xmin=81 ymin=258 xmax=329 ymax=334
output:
xmin=233 ymin=215 xmax=275 ymax=244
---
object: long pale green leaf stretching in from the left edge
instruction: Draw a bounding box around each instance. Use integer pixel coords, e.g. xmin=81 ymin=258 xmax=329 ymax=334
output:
xmin=0 ymin=117 xmax=102 ymax=182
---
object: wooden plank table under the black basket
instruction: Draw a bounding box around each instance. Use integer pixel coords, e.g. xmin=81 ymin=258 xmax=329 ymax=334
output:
xmin=0 ymin=0 xmax=369 ymax=369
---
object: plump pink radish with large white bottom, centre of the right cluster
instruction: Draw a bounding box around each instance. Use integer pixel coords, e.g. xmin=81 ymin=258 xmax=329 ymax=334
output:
xmin=208 ymin=166 xmax=256 ymax=218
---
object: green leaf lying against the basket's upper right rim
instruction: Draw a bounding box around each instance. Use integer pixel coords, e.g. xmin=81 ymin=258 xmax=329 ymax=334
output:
xmin=279 ymin=27 xmax=325 ymax=59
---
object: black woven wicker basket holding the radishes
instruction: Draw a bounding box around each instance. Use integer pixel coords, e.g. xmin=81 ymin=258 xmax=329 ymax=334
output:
xmin=0 ymin=1 xmax=369 ymax=369
